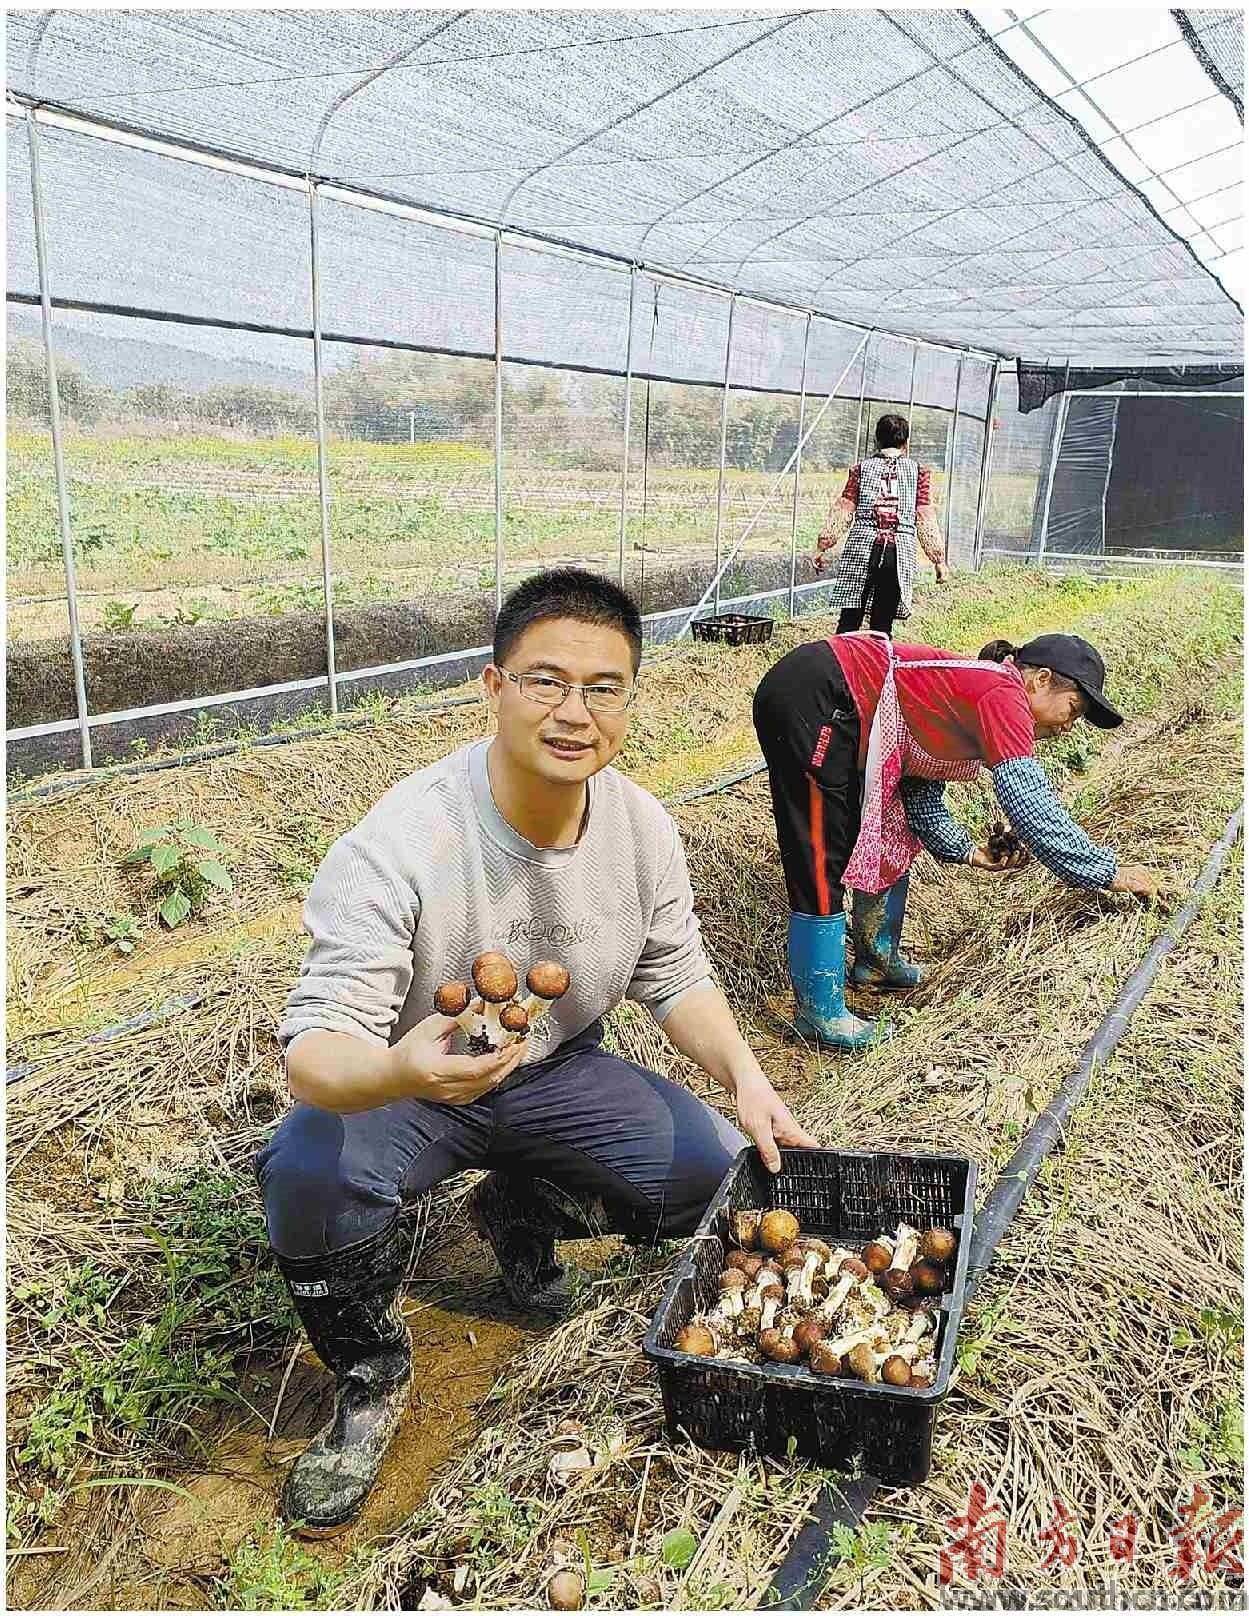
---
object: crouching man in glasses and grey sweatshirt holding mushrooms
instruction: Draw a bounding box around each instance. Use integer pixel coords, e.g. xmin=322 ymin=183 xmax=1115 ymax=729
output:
xmin=259 ymin=570 xmax=816 ymax=1534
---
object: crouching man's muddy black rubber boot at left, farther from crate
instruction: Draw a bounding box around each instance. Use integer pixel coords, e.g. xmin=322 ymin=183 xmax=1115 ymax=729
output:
xmin=278 ymin=1218 xmax=412 ymax=1537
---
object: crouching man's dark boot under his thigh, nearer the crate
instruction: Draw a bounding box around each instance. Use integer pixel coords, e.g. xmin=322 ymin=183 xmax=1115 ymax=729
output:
xmin=469 ymin=1173 xmax=611 ymax=1319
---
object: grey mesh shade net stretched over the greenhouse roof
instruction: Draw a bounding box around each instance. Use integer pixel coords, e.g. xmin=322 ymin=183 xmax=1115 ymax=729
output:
xmin=8 ymin=10 xmax=1241 ymax=364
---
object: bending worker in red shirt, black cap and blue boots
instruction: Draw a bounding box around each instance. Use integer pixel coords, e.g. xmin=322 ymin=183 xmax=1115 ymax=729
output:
xmin=755 ymin=632 xmax=1157 ymax=1049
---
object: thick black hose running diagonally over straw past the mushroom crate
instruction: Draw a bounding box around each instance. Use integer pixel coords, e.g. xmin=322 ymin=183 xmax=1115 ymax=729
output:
xmin=759 ymin=808 xmax=1244 ymax=1611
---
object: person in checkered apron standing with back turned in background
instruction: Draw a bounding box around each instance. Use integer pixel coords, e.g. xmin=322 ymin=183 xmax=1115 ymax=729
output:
xmin=814 ymin=415 xmax=948 ymax=633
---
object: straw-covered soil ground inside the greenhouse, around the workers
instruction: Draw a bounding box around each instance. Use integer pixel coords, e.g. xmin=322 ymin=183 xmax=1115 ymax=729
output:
xmin=8 ymin=570 xmax=1243 ymax=1610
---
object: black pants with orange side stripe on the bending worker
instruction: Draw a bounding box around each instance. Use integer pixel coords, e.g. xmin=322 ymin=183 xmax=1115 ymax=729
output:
xmin=755 ymin=640 xmax=863 ymax=915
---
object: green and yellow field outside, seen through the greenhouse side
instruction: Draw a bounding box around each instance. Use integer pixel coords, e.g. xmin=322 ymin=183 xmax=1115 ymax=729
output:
xmin=8 ymin=427 xmax=1032 ymax=642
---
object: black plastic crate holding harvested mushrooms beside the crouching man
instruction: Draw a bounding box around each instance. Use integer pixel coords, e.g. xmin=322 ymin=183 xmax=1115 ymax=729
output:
xmin=643 ymin=1146 xmax=976 ymax=1487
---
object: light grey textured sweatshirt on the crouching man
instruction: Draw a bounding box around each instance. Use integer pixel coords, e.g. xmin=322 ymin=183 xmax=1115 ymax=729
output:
xmin=278 ymin=740 xmax=711 ymax=1060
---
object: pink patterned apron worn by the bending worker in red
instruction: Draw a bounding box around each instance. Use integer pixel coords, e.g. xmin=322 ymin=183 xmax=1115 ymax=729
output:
xmin=829 ymin=633 xmax=997 ymax=892
